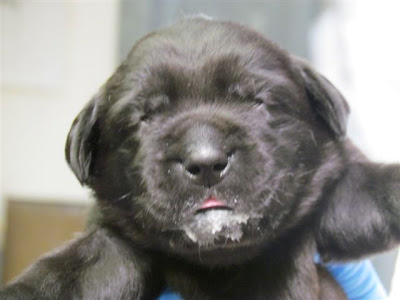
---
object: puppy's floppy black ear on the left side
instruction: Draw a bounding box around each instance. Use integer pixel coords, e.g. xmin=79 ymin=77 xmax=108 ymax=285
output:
xmin=65 ymin=92 xmax=102 ymax=185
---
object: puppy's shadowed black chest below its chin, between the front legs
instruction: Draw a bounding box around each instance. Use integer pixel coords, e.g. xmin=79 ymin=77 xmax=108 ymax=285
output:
xmin=165 ymin=233 xmax=319 ymax=299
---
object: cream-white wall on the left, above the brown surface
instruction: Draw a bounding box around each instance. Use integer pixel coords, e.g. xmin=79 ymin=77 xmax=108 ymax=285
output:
xmin=1 ymin=0 xmax=118 ymax=201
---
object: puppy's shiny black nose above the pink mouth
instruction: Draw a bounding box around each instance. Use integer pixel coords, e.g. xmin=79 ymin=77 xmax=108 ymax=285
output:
xmin=184 ymin=145 xmax=229 ymax=187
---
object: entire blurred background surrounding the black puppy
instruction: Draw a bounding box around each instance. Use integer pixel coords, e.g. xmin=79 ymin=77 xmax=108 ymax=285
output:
xmin=0 ymin=0 xmax=400 ymax=299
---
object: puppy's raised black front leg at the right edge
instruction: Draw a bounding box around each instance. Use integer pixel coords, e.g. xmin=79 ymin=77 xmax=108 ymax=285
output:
xmin=315 ymin=143 xmax=400 ymax=261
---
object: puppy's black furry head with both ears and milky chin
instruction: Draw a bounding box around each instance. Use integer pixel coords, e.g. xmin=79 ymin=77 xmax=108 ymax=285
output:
xmin=66 ymin=19 xmax=348 ymax=264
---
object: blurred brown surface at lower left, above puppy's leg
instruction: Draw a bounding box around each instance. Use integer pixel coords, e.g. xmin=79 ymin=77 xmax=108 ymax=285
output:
xmin=3 ymin=200 xmax=87 ymax=283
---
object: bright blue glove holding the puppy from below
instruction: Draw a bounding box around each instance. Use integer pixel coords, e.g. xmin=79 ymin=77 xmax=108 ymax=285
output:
xmin=158 ymin=257 xmax=387 ymax=300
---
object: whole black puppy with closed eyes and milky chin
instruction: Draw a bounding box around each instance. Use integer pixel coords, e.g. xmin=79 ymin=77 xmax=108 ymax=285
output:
xmin=1 ymin=18 xmax=400 ymax=300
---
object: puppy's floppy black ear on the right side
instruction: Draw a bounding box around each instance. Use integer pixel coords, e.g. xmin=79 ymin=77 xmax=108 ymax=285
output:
xmin=292 ymin=57 xmax=349 ymax=138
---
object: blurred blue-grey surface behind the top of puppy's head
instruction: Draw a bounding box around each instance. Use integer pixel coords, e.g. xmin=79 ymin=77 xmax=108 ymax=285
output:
xmin=119 ymin=0 xmax=321 ymax=59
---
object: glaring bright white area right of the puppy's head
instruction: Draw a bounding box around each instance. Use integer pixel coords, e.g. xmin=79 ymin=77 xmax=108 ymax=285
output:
xmin=312 ymin=0 xmax=400 ymax=162
